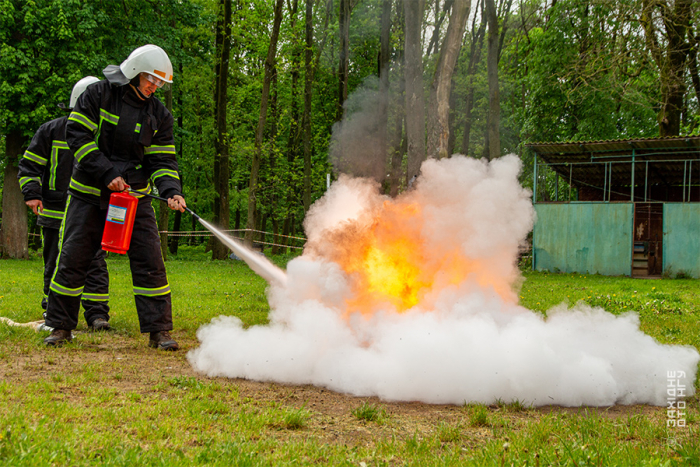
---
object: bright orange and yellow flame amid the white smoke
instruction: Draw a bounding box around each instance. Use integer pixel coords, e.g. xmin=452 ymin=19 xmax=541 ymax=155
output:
xmin=309 ymin=192 xmax=517 ymax=315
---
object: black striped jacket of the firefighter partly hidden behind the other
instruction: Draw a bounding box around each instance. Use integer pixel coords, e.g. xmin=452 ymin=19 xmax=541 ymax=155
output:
xmin=17 ymin=116 xmax=73 ymax=229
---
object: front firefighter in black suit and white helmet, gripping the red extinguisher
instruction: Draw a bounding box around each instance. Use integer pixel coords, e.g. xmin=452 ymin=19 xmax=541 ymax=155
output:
xmin=44 ymin=45 xmax=186 ymax=350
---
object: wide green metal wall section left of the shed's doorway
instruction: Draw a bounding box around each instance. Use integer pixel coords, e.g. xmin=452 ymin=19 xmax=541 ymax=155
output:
xmin=532 ymin=203 xmax=634 ymax=276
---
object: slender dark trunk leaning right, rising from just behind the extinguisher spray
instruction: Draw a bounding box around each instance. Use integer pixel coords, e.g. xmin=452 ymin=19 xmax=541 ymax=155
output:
xmin=245 ymin=0 xmax=284 ymax=246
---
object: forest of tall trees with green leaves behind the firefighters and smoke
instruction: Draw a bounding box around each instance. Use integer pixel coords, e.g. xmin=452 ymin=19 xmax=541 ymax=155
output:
xmin=0 ymin=0 xmax=700 ymax=259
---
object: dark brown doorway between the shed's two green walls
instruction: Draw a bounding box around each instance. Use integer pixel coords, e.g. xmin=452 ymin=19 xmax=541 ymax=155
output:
xmin=632 ymin=203 xmax=664 ymax=277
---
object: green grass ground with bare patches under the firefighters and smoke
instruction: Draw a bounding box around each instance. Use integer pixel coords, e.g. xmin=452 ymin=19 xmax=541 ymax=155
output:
xmin=0 ymin=260 xmax=700 ymax=466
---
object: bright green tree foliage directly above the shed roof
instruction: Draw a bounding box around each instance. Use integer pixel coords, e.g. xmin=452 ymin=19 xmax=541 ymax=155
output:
xmin=504 ymin=0 xmax=658 ymax=141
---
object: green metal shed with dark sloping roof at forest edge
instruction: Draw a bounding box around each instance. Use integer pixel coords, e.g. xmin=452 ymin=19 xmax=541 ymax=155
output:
xmin=525 ymin=136 xmax=700 ymax=278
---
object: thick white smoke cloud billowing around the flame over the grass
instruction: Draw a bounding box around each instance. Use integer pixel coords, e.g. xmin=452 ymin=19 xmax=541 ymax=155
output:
xmin=188 ymin=156 xmax=700 ymax=406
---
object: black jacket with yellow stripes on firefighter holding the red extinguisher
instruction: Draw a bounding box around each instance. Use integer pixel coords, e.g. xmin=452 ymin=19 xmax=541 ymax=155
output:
xmin=66 ymin=80 xmax=182 ymax=209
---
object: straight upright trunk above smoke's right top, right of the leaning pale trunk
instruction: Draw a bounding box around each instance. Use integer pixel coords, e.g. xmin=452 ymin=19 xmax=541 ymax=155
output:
xmin=485 ymin=0 xmax=501 ymax=160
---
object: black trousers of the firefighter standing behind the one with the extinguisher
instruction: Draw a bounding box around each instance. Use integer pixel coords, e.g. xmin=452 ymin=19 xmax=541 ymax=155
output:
xmin=41 ymin=226 xmax=109 ymax=325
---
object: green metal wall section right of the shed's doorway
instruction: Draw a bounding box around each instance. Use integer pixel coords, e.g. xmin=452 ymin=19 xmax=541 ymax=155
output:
xmin=663 ymin=203 xmax=700 ymax=278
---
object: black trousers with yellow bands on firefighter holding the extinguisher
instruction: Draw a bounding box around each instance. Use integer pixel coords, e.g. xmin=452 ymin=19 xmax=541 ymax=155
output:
xmin=46 ymin=195 xmax=173 ymax=333
